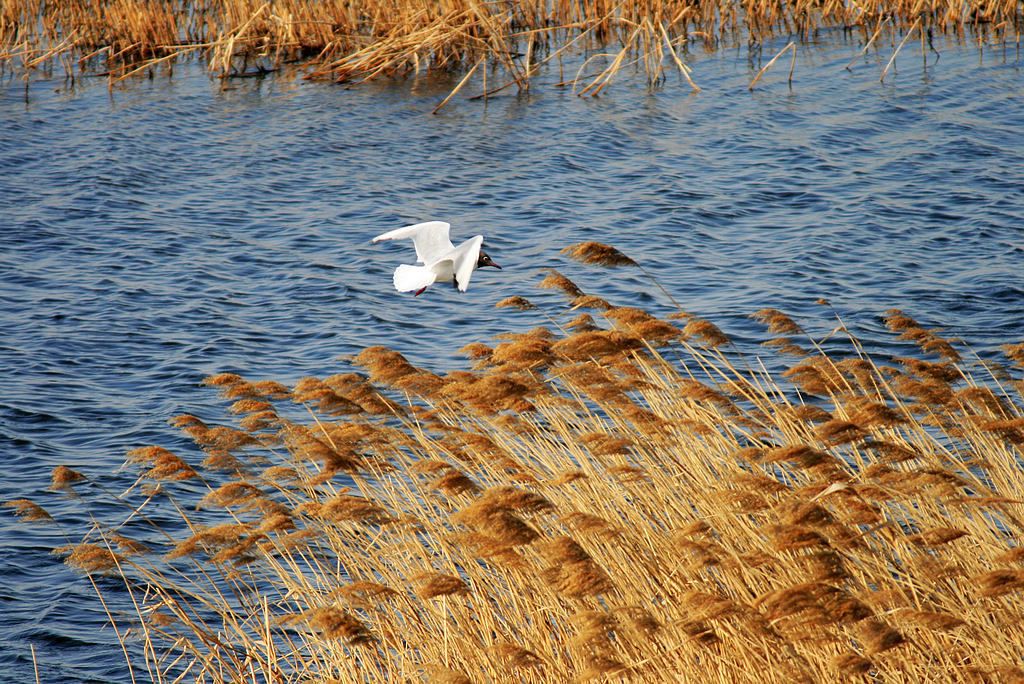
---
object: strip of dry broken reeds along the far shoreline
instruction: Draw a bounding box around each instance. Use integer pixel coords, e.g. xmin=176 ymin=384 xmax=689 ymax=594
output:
xmin=0 ymin=0 xmax=1024 ymax=94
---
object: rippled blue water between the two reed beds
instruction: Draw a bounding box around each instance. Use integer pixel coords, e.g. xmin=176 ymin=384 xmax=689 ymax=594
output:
xmin=0 ymin=36 xmax=1024 ymax=682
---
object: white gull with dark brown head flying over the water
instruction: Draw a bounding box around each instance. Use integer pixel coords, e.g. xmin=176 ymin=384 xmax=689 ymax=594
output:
xmin=374 ymin=221 xmax=501 ymax=295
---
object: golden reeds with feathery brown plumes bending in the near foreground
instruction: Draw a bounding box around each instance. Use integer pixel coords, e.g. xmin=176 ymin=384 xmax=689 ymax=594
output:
xmin=8 ymin=243 xmax=1024 ymax=683
